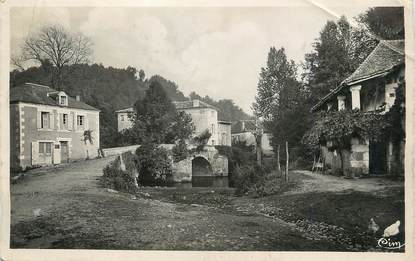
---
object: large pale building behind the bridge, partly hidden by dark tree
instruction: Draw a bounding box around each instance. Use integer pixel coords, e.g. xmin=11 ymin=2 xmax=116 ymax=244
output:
xmin=116 ymin=100 xmax=231 ymax=146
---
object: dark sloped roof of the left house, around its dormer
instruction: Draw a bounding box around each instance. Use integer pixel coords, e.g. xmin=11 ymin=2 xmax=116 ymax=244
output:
xmin=10 ymin=83 xmax=99 ymax=111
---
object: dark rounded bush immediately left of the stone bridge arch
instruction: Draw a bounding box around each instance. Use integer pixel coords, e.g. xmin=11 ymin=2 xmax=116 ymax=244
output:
xmin=136 ymin=143 xmax=172 ymax=185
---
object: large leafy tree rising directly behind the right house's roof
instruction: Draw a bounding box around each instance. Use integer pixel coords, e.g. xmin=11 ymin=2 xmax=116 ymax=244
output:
xmin=302 ymin=16 xmax=377 ymax=103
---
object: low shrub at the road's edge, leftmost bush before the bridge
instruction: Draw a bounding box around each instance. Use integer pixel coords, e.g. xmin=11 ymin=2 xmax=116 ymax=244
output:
xmin=101 ymin=152 xmax=137 ymax=192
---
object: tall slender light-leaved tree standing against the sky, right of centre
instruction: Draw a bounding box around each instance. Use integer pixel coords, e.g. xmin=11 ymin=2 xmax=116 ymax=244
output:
xmin=253 ymin=47 xmax=297 ymax=121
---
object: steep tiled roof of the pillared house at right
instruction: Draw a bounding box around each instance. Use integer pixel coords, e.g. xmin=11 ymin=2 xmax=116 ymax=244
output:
xmin=311 ymin=40 xmax=405 ymax=111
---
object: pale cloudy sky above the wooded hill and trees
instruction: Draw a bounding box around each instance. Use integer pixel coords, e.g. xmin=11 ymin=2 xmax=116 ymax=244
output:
xmin=10 ymin=5 xmax=380 ymax=113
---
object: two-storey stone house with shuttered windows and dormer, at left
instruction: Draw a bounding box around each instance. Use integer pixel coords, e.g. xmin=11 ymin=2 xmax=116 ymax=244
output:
xmin=10 ymin=83 xmax=100 ymax=169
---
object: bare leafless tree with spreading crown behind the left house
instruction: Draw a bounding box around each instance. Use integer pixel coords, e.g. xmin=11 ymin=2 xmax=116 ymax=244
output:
xmin=18 ymin=26 xmax=92 ymax=90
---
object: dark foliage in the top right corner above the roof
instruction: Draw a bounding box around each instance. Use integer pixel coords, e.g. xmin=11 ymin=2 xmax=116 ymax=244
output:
xmin=357 ymin=7 xmax=405 ymax=40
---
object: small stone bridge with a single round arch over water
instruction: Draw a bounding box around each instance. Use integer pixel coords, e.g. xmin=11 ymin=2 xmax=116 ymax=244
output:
xmin=172 ymin=146 xmax=228 ymax=182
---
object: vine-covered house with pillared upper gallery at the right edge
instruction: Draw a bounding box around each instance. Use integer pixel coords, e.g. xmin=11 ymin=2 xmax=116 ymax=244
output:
xmin=312 ymin=40 xmax=405 ymax=175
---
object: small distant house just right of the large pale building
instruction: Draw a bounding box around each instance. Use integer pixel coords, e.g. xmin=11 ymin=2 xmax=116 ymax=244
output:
xmin=232 ymin=120 xmax=274 ymax=156
